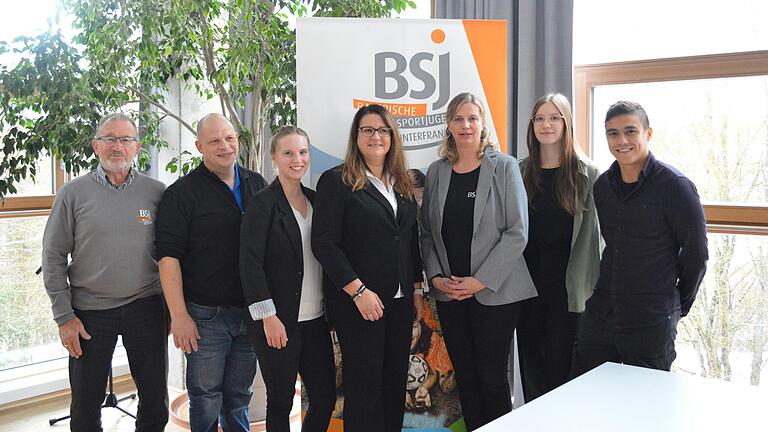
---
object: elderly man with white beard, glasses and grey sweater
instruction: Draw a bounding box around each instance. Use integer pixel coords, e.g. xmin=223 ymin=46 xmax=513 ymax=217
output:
xmin=43 ymin=114 xmax=168 ymax=432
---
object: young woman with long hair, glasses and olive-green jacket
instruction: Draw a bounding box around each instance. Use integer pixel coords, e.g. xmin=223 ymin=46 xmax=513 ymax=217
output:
xmin=517 ymin=94 xmax=600 ymax=402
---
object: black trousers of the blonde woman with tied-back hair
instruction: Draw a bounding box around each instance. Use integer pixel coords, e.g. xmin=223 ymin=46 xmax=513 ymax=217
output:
xmin=251 ymin=317 xmax=336 ymax=432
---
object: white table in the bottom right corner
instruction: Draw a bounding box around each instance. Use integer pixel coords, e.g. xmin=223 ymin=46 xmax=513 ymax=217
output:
xmin=478 ymin=363 xmax=768 ymax=432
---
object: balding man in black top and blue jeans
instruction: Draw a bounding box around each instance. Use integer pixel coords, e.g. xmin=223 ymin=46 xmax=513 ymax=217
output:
xmin=155 ymin=114 xmax=266 ymax=431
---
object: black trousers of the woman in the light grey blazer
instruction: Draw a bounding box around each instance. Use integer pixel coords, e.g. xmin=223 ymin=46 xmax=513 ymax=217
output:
xmin=437 ymin=297 xmax=520 ymax=430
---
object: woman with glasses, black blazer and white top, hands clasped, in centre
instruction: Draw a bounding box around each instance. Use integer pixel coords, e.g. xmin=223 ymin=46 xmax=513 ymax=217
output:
xmin=312 ymin=105 xmax=421 ymax=432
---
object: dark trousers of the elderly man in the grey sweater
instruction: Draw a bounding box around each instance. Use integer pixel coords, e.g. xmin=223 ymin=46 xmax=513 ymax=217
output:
xmin=69 ymin=295 xmax=168 ymax=432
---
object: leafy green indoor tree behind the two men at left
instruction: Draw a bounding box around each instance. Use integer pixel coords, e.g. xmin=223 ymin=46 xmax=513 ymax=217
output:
xmin=0 ymin=0 xmax=408 ymax=198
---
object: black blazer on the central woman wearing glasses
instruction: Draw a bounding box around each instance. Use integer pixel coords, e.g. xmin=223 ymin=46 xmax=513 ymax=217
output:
xmin=312 ymin=166 xmax=422 ymax=307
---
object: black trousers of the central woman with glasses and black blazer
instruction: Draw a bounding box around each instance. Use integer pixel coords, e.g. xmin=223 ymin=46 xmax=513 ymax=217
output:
xmin=328 ymin=297 xmax=413 ymax=432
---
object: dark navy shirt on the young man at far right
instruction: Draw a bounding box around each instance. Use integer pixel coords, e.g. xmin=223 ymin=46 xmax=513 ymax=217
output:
xmin=587 ymin=154 xmax=708 ymax=328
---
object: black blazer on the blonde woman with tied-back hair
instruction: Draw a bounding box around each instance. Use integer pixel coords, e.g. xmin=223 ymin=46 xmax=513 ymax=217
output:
xmin=240 ymin=178 xmax=315 ymax=339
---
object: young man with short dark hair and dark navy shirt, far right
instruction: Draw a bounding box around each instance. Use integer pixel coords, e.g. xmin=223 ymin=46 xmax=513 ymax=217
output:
xmin=575 ymin=102 xmax=708 ymax=374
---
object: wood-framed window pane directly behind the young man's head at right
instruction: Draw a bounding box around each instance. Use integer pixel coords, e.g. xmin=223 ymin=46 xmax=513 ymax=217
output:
xmin=574 ymin=51 xmax=768 ymax=232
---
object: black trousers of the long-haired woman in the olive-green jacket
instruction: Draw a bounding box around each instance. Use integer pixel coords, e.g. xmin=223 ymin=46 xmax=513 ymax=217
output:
xmin=517 ymin=297 xmax=581 ymax=402
